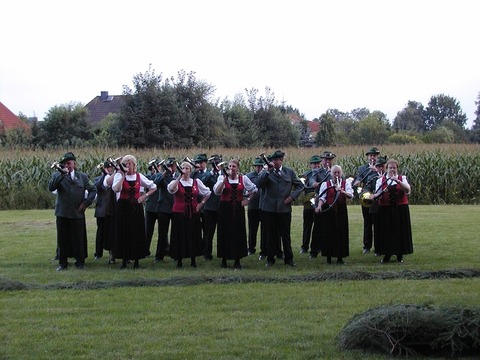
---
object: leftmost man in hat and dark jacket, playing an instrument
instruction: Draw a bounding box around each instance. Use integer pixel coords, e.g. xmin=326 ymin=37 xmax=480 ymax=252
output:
xmin=48 ymin=152 xmax=97 ymax=271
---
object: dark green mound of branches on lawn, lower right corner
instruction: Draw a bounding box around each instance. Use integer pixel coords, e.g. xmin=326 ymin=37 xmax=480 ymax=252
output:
xmin=339 ymin=305 xmax=480 ymax=356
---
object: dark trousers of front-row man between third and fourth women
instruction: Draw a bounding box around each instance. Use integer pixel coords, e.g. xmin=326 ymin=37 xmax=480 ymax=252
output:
xmin=262 ymin=211 xmax=293 ymax=264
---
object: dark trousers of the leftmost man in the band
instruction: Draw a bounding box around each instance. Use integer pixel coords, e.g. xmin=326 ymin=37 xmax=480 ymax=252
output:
xmin=57 ymin=216 xmax=87 ymax=267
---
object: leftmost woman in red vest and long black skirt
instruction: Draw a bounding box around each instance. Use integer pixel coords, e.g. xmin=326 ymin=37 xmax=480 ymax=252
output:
xmin=112 ymin=155 xmax=157 ymax=269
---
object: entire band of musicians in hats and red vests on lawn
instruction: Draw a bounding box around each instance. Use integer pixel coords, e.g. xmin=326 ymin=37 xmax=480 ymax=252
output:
xmin=49 ymin=148 xmax=413 ymax=271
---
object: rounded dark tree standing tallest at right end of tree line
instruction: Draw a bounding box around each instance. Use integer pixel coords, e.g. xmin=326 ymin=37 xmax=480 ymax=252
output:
xmin=424 ymin=94 xmax=467 ymax=131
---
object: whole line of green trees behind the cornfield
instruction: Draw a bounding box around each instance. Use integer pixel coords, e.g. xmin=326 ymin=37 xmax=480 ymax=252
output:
xmin=0 ymin=67 xmax=480 ymax=149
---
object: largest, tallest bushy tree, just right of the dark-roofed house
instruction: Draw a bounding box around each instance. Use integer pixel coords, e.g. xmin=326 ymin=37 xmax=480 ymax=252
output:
xmin=114 ymin=67 xmax=226 ymax=148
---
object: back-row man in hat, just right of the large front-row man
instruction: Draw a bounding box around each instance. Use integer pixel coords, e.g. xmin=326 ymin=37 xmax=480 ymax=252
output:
xmin=300 ymin=155 xmax=322 ymax=254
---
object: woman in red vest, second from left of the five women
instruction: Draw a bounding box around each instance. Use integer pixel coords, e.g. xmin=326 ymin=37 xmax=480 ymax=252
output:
xmin=167 ymin=161 xmax=211 ymax=268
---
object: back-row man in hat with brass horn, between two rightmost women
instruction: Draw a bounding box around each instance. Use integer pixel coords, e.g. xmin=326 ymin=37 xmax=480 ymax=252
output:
xmin=353 ymin=147 xmax=380 ymax=254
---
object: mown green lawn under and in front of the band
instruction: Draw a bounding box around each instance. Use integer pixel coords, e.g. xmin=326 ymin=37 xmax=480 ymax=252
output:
xmin=0 ymin=206 xmax=480 ymax=359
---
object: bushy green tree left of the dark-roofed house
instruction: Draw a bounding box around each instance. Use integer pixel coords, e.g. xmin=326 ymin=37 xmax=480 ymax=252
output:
xmin=35 ymin=102 xmax=92 ymax=148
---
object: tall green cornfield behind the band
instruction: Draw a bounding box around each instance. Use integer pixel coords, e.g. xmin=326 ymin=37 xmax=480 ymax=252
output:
xmin=0 ymin=144 xmax=480 ymax=210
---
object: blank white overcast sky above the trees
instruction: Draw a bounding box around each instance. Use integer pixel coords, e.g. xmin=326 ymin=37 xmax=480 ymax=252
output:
xmin=0 ymin=0 xmax=480 ymax=127
